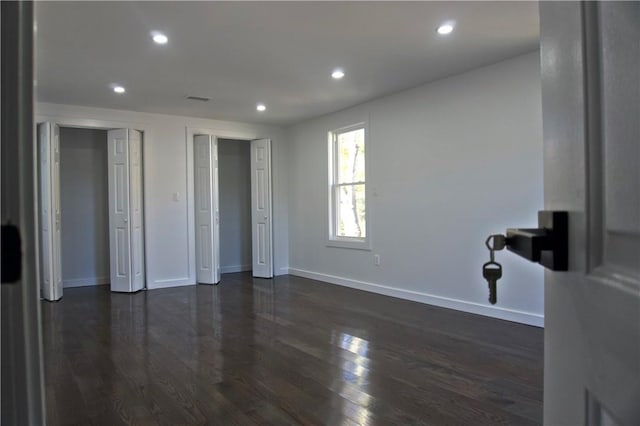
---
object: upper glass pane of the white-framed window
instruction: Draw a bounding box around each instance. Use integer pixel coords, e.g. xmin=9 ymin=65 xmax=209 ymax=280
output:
xmin=336 ymin=129 xmax=364 ymax=183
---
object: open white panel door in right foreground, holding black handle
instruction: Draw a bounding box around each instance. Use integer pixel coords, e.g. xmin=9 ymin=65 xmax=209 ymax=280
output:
xmin=540 ymin=2 xmax=640 ymax=425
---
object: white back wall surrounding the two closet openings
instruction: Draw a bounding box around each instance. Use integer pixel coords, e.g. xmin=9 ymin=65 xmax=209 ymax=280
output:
xmin=36 ymin=103 xmax=289 ymax=288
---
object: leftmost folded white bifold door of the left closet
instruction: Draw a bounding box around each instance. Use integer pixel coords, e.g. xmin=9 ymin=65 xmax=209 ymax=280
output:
xmin=38 ymin=122 xmax=62 ymax=301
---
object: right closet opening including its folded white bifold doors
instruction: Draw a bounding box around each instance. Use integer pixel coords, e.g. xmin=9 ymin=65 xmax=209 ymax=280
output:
xmin=187 ymin=129 xmax=273 ymax=284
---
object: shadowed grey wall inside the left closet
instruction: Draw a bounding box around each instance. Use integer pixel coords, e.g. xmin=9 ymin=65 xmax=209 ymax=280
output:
xmin=60 ymin=127 xmax=109 ymax=287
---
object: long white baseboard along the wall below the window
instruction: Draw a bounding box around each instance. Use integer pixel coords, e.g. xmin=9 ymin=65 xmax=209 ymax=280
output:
xmin=289 ymin=268 xmax=544 ymax=327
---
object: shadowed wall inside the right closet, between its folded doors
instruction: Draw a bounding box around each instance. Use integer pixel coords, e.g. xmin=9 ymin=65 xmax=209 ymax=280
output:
xmin=218 ymin=139 xmax=251 ymax=274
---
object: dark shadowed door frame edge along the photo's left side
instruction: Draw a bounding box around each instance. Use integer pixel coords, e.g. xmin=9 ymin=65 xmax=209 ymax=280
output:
xmin=0 ymin=2 xmax=46 ymax=425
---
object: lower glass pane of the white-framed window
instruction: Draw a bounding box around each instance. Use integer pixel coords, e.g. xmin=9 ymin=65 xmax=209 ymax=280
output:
xmin=336 ymin=185 xmax=367 ymax=238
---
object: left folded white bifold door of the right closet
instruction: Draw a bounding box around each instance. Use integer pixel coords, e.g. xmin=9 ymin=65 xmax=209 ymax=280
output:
xmin=193 ymin=135 xmax=220 ymax=284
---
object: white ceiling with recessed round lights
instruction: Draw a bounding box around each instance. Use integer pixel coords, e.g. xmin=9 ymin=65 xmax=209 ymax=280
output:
xmin=36 ymin=2 xmax=538 ymax=125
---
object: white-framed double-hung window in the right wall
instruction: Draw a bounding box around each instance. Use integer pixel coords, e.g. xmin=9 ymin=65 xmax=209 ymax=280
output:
xmin=329 ymin=124 xmax=369 ymax=249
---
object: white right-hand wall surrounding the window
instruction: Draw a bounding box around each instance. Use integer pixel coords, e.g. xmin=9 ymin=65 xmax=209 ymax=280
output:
xmin=288 ymin=52 xmax=543 ymax=325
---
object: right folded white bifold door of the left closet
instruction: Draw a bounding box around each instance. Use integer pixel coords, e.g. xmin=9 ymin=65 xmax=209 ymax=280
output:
xmin=107 ymin=129 xmax=145 ymax=293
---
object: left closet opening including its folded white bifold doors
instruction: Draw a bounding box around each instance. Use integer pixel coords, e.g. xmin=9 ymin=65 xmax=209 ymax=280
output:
xmin=37 ymin=122 xmax=145 ymax=301
